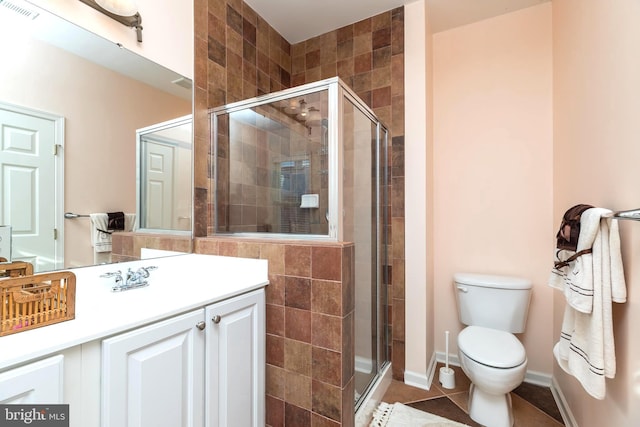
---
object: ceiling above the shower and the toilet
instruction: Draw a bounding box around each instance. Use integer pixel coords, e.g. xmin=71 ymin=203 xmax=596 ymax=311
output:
xmin=244 ymin=0 xmax=550 ymax=44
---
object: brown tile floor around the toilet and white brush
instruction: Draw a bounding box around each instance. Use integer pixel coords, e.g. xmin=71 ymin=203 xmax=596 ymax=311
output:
xmin=382 ymin=364 xmax=564 ymax=427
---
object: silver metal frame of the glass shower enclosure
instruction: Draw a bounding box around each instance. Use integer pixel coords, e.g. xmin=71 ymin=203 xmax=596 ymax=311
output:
xmin=209 ymin=77 xmax=391 ymax=410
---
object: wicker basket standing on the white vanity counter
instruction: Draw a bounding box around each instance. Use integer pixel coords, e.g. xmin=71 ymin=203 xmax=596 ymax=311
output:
xmin=0 ymin=271 xmax=76 ymax=336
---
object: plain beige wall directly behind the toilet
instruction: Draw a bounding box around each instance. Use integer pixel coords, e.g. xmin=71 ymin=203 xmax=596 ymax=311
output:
xmin=430 ymin=3 xmax=554 ymax=375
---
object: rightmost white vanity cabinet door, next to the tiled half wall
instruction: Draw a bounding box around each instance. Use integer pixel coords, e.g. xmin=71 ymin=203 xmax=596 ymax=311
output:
xmin=205 ymin=289 xmax=266 ymax=427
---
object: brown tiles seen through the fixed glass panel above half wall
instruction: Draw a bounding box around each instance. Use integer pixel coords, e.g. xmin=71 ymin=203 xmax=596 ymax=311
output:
xmin=213 ymin=98 xmax=329 ymax=235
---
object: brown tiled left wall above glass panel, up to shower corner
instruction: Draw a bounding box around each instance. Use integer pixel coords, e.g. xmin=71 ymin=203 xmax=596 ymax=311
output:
xmin=194 ymin=0 xmax=291 ymax=236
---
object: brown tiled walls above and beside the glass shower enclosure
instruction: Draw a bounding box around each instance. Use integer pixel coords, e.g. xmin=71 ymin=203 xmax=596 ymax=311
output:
xmin=194 ymin=0 xmax=405 ymax=379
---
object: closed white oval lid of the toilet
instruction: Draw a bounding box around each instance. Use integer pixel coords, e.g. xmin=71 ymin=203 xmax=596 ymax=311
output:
xmin=458 ymin=326 xmax=527 ymax=368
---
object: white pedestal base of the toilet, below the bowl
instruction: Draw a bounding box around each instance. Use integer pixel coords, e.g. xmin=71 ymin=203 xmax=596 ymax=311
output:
xmin=469 ymin=383 xmax=513 ymax=427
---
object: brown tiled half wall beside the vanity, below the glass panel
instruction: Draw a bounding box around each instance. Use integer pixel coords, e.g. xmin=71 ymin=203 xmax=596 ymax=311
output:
xmin=194 ymin=237 xmax=355 ymax=427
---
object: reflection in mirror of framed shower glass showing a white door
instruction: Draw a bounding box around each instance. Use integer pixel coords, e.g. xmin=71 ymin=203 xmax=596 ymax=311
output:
xmin=137 ymin=116 xmax=192 ymax=231
